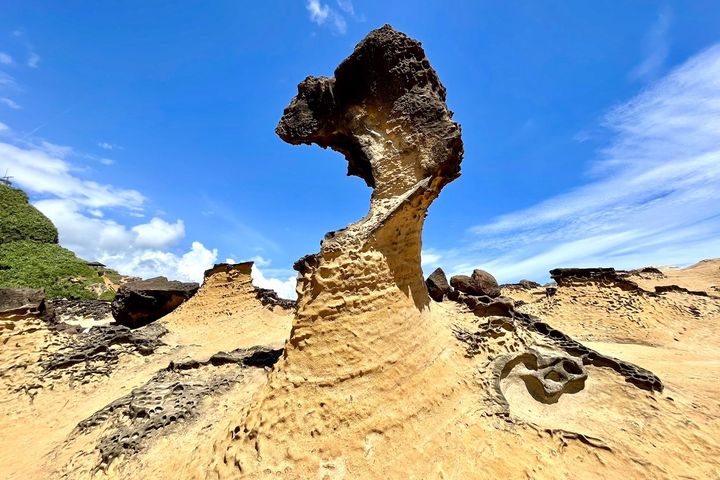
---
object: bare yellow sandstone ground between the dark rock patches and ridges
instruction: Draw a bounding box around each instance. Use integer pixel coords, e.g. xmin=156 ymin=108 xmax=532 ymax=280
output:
xmin=0 ymin=260 xmax=720 ymax=479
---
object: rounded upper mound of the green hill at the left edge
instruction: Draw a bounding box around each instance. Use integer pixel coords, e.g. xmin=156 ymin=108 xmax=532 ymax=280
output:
xmin=0 ymin=184 xmax=58 ymax=244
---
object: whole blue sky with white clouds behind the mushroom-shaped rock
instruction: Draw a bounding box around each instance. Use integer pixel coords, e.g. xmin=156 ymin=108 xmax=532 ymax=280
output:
xmin=0 ymin=0 xmax=720 ymax=296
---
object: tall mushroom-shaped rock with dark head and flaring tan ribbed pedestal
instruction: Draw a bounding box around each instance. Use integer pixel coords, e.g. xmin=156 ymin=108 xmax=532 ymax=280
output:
xmin=219 ymin=25 xmax=463 ymax=475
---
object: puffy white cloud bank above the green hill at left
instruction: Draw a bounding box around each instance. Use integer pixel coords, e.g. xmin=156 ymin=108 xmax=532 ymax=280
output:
xmin=0 ymin=134 xmax=218 ymax=282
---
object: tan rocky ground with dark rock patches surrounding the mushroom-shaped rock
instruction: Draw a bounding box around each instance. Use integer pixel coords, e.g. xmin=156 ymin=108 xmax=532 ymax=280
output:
xmin=0 ymin=260 xmax=720 ymax=479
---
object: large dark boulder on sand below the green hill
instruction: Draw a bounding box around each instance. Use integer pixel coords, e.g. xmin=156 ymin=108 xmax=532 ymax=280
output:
xmin=112 ymin=277 xmax=200 ymax=328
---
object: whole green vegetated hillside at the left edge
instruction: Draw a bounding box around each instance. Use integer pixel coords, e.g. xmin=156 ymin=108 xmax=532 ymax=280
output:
xmin=0 ymin=184 xmax=116 ymax=299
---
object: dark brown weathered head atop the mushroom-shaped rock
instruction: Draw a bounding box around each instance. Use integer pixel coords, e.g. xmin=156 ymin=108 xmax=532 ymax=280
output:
xmin=275 ymin=25 xmax=463 ymax=195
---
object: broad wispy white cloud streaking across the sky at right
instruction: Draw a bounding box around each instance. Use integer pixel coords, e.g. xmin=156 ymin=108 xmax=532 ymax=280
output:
xmin=432 ymin=44 xmax=720 ymax=281
